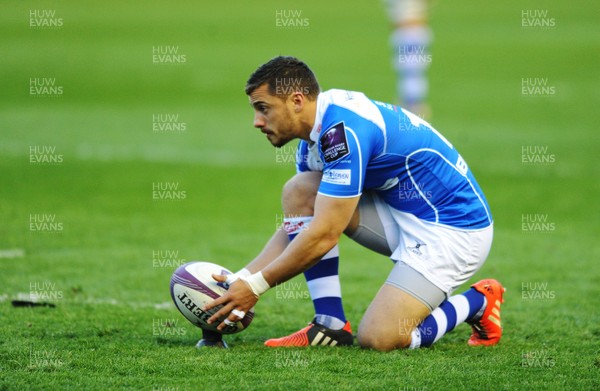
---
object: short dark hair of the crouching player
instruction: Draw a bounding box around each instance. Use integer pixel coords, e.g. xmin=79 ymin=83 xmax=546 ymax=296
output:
xmin=245 ymin=56 xmax=320 ymax=100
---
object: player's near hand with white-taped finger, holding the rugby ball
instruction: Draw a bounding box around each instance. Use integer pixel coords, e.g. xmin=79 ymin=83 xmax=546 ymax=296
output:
xmin=202 ymin=274 xmax=258 ymax=331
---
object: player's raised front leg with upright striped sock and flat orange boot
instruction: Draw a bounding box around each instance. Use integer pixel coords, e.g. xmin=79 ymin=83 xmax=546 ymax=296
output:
xmin=265 ymin=172 xmax=352 ymax=347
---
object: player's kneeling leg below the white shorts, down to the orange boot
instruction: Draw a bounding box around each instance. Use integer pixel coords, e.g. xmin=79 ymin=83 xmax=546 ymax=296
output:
xmin=358 ymin=261 xmax=504 ymax=351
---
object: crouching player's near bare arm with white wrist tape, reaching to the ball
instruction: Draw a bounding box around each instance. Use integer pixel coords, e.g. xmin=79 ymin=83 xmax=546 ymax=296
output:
xmin=204 ymin=194 xmax=360 ymax=329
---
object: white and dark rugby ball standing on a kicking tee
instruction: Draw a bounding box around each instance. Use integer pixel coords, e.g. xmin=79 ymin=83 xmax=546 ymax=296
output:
xmin=171 ymin=262 xmax=254 ymax=334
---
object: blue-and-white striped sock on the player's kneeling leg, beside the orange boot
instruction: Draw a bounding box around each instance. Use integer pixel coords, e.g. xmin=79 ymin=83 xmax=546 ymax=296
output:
xmin=410 ymin=288 xmax=486 ymax=349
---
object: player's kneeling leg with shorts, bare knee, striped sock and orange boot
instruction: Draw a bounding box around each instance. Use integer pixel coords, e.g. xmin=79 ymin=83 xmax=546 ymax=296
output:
xmin=347 ymin=198 xmax=504 ymax=350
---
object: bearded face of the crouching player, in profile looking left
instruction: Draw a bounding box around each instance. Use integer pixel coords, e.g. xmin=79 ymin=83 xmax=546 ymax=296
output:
xmin=250 ymin=84 xmax=301 ymax=147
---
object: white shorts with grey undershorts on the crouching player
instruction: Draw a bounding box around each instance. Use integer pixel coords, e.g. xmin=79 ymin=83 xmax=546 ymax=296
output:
xmin=353 ymin=192 xmax=494 ymax=308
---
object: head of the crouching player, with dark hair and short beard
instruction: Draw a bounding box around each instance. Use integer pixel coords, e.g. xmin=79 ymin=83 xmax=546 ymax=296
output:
xmin=245 ymin=56 xmax=320 ymax=147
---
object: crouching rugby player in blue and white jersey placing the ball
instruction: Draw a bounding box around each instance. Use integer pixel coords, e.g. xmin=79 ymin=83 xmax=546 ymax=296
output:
xmin=204 ymin=56 xmax=504 ymax=351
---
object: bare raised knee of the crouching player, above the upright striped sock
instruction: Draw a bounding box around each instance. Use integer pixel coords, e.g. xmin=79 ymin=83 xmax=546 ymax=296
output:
xmin=281 ymin=172 xmax=321 ymax=216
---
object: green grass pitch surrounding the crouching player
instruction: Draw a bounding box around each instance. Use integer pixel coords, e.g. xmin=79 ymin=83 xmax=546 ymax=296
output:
xmin=0 ymin=0 xmax=600 ymax=390
